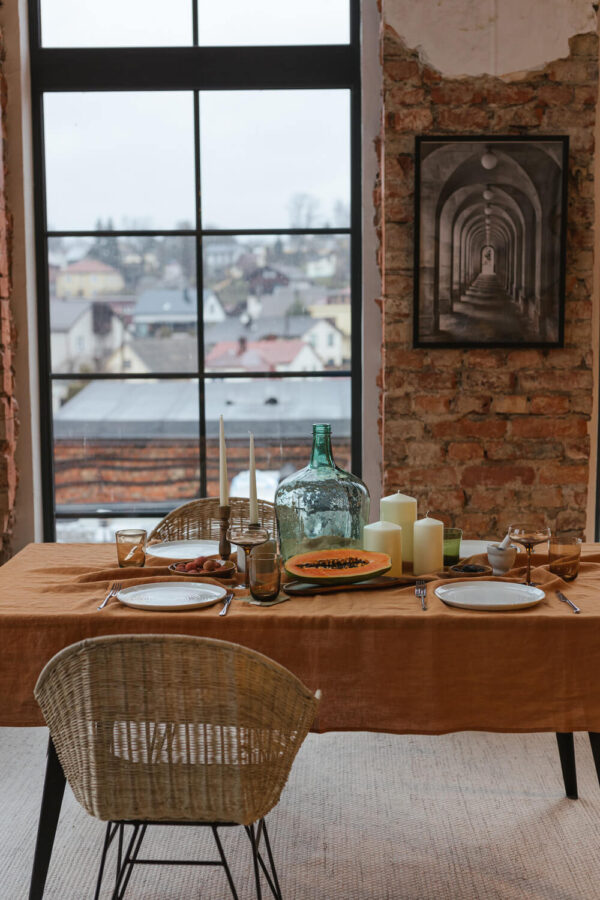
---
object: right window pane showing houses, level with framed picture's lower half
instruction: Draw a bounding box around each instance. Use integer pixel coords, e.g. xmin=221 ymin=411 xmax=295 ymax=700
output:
xmin=203 ymin=235 xmax=351 ymax=372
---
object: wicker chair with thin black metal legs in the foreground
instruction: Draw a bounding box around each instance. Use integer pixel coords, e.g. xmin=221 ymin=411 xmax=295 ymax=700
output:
xmin=34 ymin=635 xmax=319 ymax=900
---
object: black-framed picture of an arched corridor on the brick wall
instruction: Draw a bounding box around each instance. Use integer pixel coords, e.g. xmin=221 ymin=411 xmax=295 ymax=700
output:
xmin=414 ymin=135 xmax=569 ymax=347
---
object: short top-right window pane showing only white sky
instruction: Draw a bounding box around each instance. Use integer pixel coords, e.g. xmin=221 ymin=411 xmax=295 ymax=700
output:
xmin=199 ymin=0 xmax=350 ymax=47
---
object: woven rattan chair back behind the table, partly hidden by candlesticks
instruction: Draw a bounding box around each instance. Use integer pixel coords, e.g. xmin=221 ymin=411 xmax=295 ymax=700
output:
xmin=148 ymin=497 xmax=277 ymax=541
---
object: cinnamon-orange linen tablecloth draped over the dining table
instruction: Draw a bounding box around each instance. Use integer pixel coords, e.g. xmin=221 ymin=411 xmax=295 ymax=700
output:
xmin=0 ymin=544 xmax=600 ymax=734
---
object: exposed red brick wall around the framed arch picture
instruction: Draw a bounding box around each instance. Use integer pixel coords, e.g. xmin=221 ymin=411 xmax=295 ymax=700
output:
xmin=375 ymin=26 xmax=598 ymax=539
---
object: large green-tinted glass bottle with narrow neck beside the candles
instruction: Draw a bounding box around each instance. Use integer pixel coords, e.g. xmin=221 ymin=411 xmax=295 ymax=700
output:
xmin=275 ymin=425 xmax=370 ymax=560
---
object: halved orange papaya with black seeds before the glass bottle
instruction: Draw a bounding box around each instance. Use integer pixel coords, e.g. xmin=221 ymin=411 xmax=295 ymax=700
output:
xmin=285 ymin=548 xmax=392 ymax=584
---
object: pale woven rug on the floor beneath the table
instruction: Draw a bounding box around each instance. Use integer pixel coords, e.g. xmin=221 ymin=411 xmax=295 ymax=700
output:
xmin=0 ymin=728 xmax=600 ymax=900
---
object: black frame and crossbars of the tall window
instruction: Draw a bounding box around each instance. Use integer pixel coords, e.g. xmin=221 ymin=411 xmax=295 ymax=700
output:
xmin=29 ymin=0 xmax=362 ymax=541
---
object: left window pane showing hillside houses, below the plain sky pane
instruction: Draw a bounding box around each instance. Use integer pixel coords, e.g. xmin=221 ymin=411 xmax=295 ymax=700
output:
xmin=48 ymin=235 xmax=198 ymax=375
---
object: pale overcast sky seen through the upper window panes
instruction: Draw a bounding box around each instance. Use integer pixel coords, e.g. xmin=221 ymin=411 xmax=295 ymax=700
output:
xmin=42 ymin=0 xmax=350 ymax=230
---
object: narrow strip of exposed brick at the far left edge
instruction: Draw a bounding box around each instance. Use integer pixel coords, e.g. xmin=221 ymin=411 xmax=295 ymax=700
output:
xmin=0 ymin=34 xmax=17 ymax=564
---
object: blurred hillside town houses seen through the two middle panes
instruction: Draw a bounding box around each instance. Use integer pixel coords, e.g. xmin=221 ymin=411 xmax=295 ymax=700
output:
xmin=49 ymin=235 xmax=351 ymax=376
